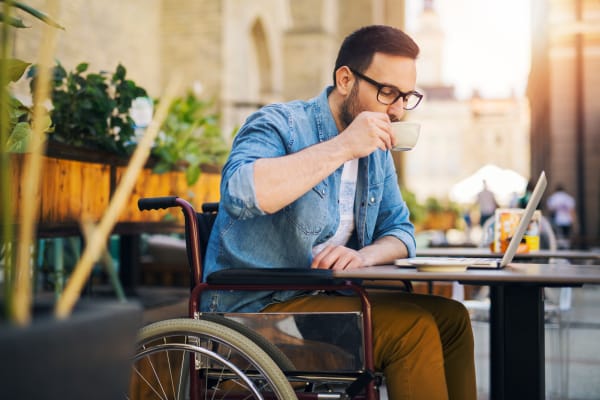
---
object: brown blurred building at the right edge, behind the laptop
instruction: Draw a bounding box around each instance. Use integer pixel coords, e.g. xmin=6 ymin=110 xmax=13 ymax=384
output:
xmin=528 ymin=0 xmax=600 ymax=247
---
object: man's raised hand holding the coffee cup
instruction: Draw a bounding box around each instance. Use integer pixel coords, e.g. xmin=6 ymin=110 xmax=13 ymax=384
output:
xmin=340 ymin=111 xmax=395 ymax=159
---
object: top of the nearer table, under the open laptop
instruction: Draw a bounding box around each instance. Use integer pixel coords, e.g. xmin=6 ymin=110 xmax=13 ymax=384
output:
xmin=333 ymin=263 xmax=600 ymax=286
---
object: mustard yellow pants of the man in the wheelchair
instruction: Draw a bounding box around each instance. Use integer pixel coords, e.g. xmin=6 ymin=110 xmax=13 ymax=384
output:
xmin=263 ymin=292 xmax=477 ymax=400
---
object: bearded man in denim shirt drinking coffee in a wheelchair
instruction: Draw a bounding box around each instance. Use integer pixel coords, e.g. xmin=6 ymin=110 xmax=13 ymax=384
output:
xmin=202 ymin=26 xmax=476 ymax=400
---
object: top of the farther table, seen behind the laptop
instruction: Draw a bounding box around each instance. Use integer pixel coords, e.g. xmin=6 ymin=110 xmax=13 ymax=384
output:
xmin=417 ymin=247 xmax=600 ymax=261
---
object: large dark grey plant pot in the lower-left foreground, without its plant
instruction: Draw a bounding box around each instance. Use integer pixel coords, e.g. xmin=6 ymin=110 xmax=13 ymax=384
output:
xmin=0 ymin=300 xmax=142 ymax=400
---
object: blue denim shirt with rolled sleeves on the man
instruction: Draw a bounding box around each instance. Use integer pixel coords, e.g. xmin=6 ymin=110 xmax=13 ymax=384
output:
xmin=201 ymin=87 xmax=415 ymax=312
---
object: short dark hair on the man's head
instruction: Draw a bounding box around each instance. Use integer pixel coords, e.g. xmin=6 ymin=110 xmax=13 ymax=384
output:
xmin=333 ymin=25 xmax=419 ymax=85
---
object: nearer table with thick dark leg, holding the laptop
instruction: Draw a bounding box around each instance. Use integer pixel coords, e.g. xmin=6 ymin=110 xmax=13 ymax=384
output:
xmin=333 ymin=263 xmax=600 ymax=400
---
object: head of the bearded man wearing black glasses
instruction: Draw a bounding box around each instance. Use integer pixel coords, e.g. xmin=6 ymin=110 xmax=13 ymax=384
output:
xmin=333 ymin=25 xmax=422 ymax=126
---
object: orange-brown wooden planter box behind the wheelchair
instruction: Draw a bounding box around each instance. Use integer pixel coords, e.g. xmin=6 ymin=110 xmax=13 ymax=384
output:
xmin=4 ymin=144 xmax=220 ymax=236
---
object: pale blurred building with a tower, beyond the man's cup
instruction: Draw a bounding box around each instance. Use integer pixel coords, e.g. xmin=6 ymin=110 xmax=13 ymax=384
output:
xmin=399 ymin=1 xmax=530 ymax=205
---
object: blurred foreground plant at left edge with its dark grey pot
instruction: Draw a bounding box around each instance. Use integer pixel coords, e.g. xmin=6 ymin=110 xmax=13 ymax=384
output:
xmin=0 ymin=0 xmax=141 ymax=399
